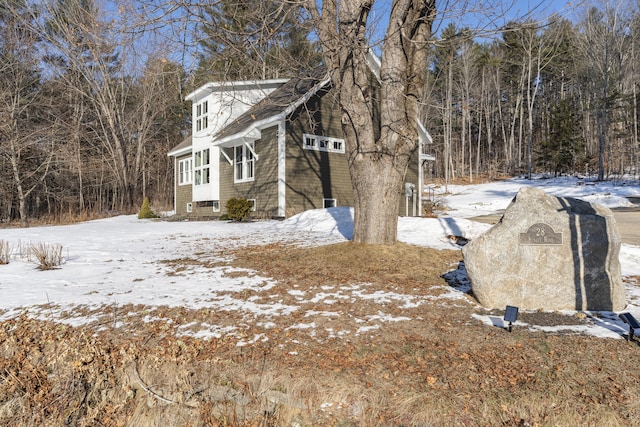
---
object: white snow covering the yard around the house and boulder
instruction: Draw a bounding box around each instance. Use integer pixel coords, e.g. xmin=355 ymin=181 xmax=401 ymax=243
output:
xmin=0 ymin=178 xmax=640 ymax=338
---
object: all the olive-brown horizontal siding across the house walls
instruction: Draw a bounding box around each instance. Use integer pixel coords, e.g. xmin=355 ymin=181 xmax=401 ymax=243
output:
xmin=174 ymin=69 xmax=430 ymax=218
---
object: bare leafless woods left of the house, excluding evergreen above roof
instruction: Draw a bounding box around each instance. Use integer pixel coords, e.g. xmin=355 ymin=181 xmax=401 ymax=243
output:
xmin=0 ymin=0 xmax=188 ymax=224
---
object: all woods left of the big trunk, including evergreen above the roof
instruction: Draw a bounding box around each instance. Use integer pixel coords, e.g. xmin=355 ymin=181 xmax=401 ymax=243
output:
xmin=0 ymin=0 xmax=319 ymax=225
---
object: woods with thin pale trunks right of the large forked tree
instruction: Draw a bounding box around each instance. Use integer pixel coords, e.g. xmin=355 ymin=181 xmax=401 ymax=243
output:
xmin=422 ymin=3 xmax=640 ymax=181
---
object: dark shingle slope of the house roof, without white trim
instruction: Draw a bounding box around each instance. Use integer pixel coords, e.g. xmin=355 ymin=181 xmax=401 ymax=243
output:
xmin=214 ymin=67 xmax=327 ymax=140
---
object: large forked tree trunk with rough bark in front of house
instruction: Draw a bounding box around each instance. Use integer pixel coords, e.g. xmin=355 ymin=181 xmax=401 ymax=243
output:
xmin=307 ymin=0 xmax=435 ymax=244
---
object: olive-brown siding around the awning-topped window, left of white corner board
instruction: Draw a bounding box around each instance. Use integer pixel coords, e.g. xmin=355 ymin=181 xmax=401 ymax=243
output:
xmin=220 ymin=125 xmax=278 ymax=217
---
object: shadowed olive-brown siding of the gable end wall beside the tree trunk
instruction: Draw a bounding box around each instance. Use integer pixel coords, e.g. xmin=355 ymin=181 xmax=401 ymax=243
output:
xmin=286 ymin=85 xmax=353 ymax=216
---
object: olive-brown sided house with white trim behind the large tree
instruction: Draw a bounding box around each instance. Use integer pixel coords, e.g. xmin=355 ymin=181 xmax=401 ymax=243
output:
xmin=168 ymin=64 xmax=433 ymax=218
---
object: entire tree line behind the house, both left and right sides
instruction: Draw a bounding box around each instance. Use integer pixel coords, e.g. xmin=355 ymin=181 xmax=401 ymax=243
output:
xmin=0 ymin=0 xmax=640 ymax=224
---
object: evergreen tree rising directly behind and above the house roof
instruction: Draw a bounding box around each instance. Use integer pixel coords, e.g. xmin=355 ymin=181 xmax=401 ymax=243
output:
xmin=196 ymin=0 xmax=320 ymax=84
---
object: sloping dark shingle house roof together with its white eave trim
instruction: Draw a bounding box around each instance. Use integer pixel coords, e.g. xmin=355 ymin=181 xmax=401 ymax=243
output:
xmin=213 ymin=67 xmax=330 ymax=146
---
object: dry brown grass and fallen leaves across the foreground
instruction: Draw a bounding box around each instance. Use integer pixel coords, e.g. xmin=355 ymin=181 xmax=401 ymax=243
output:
xmin=0 ymin=243 xmax=640 ymax=426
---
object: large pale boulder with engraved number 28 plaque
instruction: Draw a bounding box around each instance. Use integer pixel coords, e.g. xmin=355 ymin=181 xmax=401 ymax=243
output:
xmin=462 ymin=188 xmax=626 ymax=311
